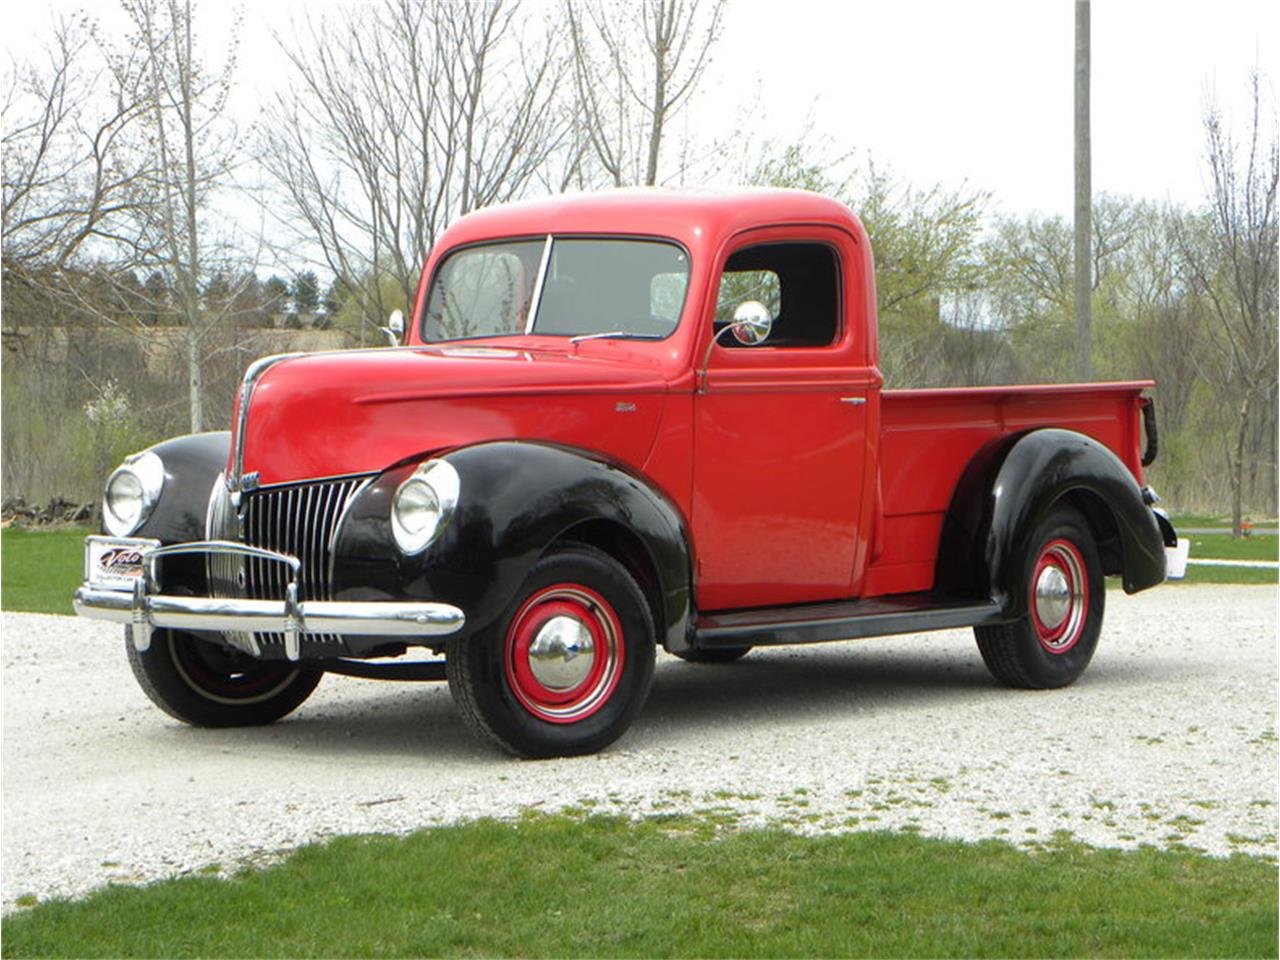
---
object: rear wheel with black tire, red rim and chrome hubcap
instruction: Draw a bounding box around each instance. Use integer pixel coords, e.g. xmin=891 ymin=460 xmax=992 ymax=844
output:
xmin=974 ymin=506 xmax=1106 ymax=689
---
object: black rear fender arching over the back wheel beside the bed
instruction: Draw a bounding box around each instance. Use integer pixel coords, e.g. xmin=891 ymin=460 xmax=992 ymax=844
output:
xmin=937 ymin=429 xmax=1165 ymax=617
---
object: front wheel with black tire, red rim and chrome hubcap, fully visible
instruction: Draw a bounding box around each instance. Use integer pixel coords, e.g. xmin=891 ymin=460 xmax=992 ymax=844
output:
xmin=445 ymin=545 xmax=655 ymax=759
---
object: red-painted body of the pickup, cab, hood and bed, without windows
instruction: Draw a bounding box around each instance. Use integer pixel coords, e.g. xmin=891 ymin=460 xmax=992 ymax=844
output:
xmin=232 ymin=191 xmax=1152 ymax=611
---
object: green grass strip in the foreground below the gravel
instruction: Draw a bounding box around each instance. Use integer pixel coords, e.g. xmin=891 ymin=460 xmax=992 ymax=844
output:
xmin=3 ymin=817 xmax=1277 ymax=956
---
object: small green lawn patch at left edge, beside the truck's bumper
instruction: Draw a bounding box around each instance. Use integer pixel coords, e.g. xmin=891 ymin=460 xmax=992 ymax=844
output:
xmin=0 ymin=526 xmax=93 ymax=613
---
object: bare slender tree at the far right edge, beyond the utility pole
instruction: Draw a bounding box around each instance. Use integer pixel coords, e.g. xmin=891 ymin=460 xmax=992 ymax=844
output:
xmin=1179 ymin=74 xmax=1280 ymax=536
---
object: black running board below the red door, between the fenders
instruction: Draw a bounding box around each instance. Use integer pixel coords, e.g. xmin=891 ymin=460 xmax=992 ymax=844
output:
xmin=692 ymin=593 xmax=1005 ymax=650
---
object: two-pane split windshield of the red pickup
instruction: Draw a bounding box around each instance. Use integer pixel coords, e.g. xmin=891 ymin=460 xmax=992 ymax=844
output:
xmin=422 ymin=238 xmax=689 ymax=343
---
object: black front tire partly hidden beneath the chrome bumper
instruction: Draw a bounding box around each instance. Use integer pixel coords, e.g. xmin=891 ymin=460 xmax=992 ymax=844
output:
xmin=124 ymin=630 xmax=323 ymax=727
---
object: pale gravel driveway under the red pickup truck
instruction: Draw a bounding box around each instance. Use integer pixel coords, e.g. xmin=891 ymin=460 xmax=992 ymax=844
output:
xmin=3 ymin=586 xmax=1277 ymax=909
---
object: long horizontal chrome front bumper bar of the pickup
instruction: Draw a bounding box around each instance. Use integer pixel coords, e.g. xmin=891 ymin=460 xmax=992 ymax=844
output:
xmin=74 ymin=591 xmax=466 ymax=642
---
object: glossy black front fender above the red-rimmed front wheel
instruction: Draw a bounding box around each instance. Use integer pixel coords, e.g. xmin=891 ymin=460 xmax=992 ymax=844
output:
xmin=333 ymin=442 xmax=692 ymax=649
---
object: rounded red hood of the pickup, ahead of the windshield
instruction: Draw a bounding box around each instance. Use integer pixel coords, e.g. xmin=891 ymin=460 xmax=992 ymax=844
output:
xmin=232 ymin=344 xmax=667 ymax=485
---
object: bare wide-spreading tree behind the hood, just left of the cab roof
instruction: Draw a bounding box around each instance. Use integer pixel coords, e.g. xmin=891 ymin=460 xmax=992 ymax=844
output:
xmin=262 ymin=0 xmax=572 ymax=343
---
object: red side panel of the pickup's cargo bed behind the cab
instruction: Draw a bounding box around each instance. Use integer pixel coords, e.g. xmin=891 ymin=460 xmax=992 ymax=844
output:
xmin=861 ymin=380 xmax=1155 ymax=596
